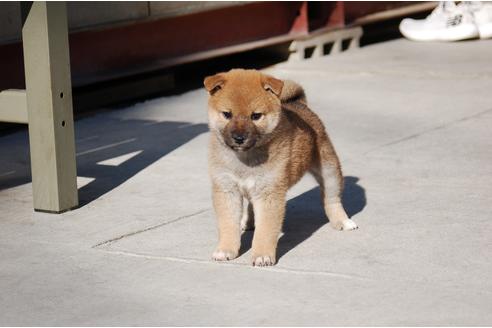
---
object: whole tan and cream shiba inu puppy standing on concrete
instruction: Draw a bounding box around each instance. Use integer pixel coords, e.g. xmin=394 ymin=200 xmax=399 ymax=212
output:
xmin=204 ymin=69 xmax=357 ymax=266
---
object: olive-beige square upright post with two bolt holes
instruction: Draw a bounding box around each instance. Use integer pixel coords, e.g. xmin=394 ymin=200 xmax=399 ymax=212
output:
xmin=21 ymin=1 xmax=78 ymax=213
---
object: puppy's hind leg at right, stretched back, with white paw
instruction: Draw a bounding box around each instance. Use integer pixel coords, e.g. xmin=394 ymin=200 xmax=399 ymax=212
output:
xmin=310 ymin=159 xmax=358 ymax=230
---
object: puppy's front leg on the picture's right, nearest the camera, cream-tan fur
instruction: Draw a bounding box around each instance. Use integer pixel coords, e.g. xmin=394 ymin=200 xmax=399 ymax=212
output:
xmin=251 ymin=193 xmax=285 ymax=266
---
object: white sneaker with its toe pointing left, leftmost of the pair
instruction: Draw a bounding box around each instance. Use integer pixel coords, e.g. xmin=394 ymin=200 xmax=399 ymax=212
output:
xmin=400 ymin=1 xmax=479 ymax=41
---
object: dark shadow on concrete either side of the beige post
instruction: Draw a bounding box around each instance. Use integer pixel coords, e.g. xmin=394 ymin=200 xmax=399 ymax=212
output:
xmin=0 ymin=116 xmax=208 ymax=207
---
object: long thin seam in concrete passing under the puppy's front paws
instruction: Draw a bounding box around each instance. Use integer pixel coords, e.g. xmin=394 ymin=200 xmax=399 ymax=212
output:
xmin=102 ymin=249 xmax=372 ymax=281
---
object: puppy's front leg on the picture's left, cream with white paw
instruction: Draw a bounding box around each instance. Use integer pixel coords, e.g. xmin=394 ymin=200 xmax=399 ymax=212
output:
xmin=212 ymin=186 xmax=243 ymax=261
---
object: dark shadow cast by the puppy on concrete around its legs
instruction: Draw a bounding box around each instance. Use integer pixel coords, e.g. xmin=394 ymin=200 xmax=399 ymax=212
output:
xmin=239 ymin=176 xmax=367 ymax=260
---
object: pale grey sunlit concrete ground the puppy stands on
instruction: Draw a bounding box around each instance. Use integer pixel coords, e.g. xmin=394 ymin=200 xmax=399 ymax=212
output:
xmin=0 ymin=40 xmax=492 ymax=326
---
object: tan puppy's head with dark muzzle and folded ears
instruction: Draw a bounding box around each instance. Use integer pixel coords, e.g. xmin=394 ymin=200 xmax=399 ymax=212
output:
xmin=204 ymin=69 xmax=283 ymax=151
